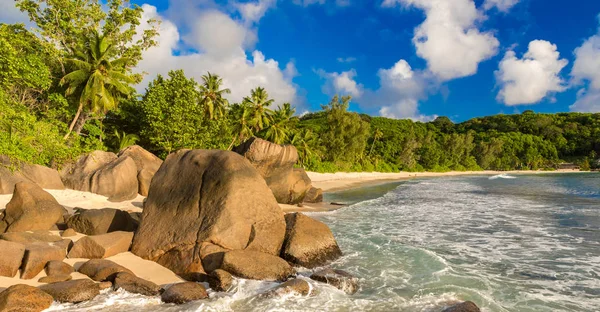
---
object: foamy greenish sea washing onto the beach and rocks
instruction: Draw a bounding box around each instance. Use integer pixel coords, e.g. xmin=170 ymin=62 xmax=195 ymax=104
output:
xmin=50 ymin=173 xmax=600 ymax=312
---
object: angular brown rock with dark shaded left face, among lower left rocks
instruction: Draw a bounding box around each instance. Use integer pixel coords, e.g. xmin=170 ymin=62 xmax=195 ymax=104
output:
xmin=21 ymin=243 xmax=65 ymax=279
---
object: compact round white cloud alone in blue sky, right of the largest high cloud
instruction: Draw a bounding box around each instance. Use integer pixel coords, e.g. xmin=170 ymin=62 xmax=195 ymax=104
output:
xmin=496 ymin=40 xmax=568 ymax=106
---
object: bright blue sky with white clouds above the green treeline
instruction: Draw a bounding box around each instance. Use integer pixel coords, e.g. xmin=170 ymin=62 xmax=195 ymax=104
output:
xmin=0 ymin=0 xmax=600 ymax=122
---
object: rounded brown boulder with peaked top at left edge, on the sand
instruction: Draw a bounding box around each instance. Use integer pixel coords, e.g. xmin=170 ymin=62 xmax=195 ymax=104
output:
xmin=0 ymin=182 xmax=63 ymax=232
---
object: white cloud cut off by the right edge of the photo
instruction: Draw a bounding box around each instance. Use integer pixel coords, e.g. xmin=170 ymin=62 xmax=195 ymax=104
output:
xmin=570 ymin=20 xmax=600 ymax=112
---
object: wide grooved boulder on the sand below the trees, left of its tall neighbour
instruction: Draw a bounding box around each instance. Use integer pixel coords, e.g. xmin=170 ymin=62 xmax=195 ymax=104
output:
xmin=61 ymin=151 xmax=138 ymax=201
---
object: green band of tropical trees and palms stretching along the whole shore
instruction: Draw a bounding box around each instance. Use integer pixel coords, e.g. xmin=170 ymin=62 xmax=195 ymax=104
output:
xmin=0 ymin=0 xmax=600 ymax=172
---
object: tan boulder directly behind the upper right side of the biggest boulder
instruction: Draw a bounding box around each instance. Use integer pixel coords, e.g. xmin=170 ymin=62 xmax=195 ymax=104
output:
xmin=234 ymin=138 xmax=311 ymax=204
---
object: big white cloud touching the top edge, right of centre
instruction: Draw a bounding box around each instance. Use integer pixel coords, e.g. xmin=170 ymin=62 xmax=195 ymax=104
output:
xmin=382 ymin=0 xmax=500 ymax=81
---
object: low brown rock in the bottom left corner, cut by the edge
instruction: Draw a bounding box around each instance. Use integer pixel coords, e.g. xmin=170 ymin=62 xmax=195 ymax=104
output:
xmin=0 ymin=284 xmax=52 ymax=312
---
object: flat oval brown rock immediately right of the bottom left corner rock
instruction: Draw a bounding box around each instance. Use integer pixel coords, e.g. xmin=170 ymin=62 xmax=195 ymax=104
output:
xmin=40 ymin=279 xmax=100 ymax=303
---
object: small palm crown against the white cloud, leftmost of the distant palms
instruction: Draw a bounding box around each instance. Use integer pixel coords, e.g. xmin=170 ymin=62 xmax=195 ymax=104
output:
xmin=200 ymin=72 xmax=231 ymax=120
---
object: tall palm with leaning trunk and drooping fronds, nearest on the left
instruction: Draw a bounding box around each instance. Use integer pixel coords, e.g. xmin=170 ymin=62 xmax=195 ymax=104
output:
xmin=60 ymin=32 xmax=135 ymax=139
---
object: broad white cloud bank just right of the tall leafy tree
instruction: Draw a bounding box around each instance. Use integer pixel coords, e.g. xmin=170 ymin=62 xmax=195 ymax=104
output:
xmin=138 ymin=4 xmax=302 ymax=104
